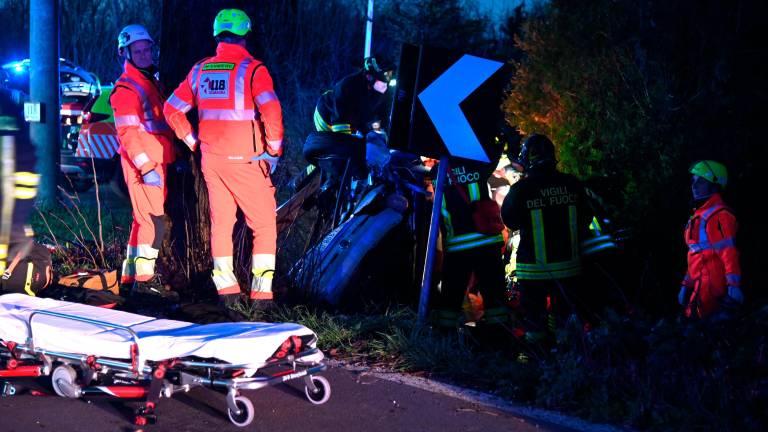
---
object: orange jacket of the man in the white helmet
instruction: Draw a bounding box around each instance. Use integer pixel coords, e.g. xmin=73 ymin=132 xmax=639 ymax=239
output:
xmin=109 ymin=61 xmax=175 ymax=174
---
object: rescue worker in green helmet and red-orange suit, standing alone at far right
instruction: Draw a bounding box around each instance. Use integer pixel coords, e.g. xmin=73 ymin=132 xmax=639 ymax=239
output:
xmin=678 ymin=160 xmax=744 ymax=318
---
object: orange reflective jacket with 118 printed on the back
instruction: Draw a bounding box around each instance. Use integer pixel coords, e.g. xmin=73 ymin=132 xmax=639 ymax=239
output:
xmin=164 ymin=42 xmax=283 ymax=162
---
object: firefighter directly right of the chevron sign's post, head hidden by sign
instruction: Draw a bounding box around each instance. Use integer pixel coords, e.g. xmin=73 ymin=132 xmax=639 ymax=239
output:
xmin=432 ymin=152 xmax=508 ymax=336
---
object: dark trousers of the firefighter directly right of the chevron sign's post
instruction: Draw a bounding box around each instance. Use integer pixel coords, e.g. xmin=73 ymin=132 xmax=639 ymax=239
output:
xmin=435 ymin=244 xmax=505 ymax=313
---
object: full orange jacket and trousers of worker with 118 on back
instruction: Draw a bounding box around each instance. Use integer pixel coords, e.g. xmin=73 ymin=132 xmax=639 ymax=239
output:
xmin=164 ymin=42 xmax=283 ymax=300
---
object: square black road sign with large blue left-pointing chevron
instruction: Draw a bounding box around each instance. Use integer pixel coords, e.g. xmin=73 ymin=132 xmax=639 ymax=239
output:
xmin=390 ymin=45 xmax=509 ymax=162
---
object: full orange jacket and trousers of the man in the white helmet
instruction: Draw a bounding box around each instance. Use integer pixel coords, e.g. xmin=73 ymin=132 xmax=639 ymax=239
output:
xmin=109 ymin=61 xmax=175 ymax=283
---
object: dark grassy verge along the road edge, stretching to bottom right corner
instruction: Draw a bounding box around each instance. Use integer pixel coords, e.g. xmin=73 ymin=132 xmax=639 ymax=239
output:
xmin=234 ymin=300 xmax=768 ymax=430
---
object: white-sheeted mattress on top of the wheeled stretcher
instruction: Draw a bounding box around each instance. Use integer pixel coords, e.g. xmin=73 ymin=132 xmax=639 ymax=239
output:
xmin=0 ymin=294 xmax=314 ymax=367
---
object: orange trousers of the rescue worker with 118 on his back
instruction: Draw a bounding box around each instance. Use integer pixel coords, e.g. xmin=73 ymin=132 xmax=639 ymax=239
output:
xmin=202 ymin=153 xmax=277 ymax=300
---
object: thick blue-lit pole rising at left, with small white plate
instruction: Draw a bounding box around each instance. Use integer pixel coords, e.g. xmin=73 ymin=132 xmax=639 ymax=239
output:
xmin=29 ymin=0 xmax=61 ymax=207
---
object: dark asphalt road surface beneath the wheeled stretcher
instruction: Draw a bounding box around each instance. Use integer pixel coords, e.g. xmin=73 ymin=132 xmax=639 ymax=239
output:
xmin=0 ymin=368 xmax=564 ymax=432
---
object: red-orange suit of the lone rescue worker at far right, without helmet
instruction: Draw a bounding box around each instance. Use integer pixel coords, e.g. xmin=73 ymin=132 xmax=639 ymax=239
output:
xmin=683 ymin=194 xmax=741 ymax=317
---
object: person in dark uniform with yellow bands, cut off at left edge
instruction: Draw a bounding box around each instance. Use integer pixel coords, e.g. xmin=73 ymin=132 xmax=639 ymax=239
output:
xmin=0 ymin=89 xmax=40 ymax=273
